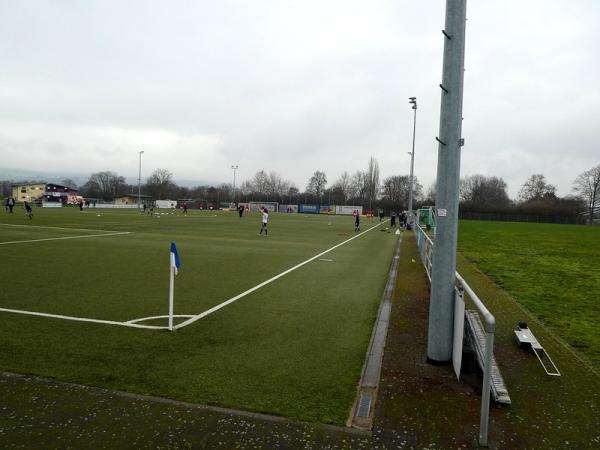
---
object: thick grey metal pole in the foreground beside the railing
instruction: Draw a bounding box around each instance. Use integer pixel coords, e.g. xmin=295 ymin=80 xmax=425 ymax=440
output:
xmin=427 ymin=0 xmax=466 ymax=363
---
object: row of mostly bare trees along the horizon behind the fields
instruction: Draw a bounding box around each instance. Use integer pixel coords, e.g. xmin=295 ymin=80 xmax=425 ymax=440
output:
xmin=0 ymin=161 xmax=600 ymax=223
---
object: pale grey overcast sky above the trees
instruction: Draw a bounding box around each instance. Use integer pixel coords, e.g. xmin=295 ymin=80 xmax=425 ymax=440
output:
xmin=0 ymin=0 xmax=600 ymax=197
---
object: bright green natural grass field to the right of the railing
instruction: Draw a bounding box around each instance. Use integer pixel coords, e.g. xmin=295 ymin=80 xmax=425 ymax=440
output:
xmin=458 ymin=221 xmax=600 ymax=371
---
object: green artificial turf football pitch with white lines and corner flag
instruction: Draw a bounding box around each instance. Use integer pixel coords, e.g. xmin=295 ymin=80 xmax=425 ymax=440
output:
xmin=0 ymin=208 xmax=397 ymax=424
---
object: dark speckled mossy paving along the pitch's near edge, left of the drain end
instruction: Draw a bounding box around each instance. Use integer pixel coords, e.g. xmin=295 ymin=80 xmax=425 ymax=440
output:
xmin=0 ymin=374 xmax=374 ymax=449
